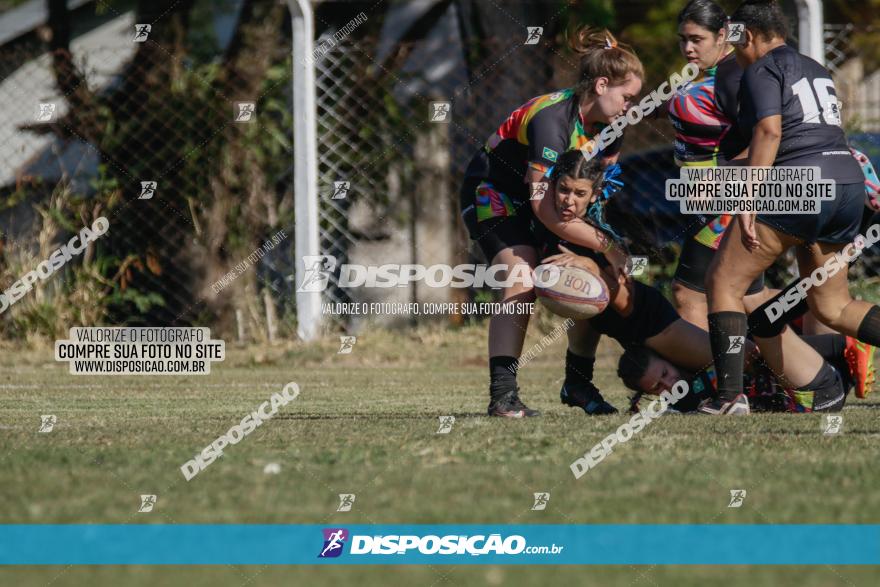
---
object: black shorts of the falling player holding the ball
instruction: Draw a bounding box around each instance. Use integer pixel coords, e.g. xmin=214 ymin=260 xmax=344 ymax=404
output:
xmin=590 ymin=281 xmax=681 ymax=345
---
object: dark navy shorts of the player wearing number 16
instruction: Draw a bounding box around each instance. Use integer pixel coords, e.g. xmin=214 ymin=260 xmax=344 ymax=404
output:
xmin=757 ymin=183 xmax=865 ymax=244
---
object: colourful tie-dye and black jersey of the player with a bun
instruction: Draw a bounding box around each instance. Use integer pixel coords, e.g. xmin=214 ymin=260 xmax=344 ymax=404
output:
xmin=462 ymin=88 xmax=621 ymax=221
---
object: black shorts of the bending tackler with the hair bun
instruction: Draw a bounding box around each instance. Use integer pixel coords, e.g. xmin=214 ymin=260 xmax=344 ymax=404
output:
xmin=460 ymin=177 xmax=538 ymax=263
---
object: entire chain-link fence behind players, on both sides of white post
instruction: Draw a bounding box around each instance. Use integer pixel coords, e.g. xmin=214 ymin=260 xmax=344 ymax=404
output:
xmin=0 ymin=5 xmax=880 ymax=340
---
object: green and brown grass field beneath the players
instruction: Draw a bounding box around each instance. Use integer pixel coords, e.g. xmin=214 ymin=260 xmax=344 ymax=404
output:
xmin=0 ymin=326 xmax=880 ymax=587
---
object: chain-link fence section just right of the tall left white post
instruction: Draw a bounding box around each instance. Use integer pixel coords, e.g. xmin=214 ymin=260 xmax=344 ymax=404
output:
xmin=316 ymin=31 xmax=696 ymax=330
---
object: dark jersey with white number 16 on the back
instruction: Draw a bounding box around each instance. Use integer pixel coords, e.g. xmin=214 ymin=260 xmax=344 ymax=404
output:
xmin=739 ymin=45 xmax=864 ymax=183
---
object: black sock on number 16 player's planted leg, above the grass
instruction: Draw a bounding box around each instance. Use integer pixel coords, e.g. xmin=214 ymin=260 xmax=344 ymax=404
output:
xmin=709 ymin=312 xmax=746 ymax=401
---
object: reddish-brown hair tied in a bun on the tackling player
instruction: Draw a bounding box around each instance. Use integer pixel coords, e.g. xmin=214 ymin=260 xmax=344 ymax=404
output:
xmin=566 ymin=26 xmax=645 ymax=97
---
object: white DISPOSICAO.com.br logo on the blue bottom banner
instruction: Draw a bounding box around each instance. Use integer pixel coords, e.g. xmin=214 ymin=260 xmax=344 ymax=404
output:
xmin=318 ymin=528 xmax=565 ymax=558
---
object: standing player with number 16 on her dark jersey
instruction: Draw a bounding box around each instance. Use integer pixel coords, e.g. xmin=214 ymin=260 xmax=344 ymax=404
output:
xmin=700 ymin=0 xmax=880 ymax=414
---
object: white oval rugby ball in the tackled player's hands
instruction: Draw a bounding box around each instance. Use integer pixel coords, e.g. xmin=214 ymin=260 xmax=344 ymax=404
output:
xmin=535 ymin=267 xmax=608 ymax=320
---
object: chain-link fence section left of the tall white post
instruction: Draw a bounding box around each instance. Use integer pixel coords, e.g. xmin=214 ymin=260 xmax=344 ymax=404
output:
xmin=0 ymin=11 xmax=294 ymax=340
